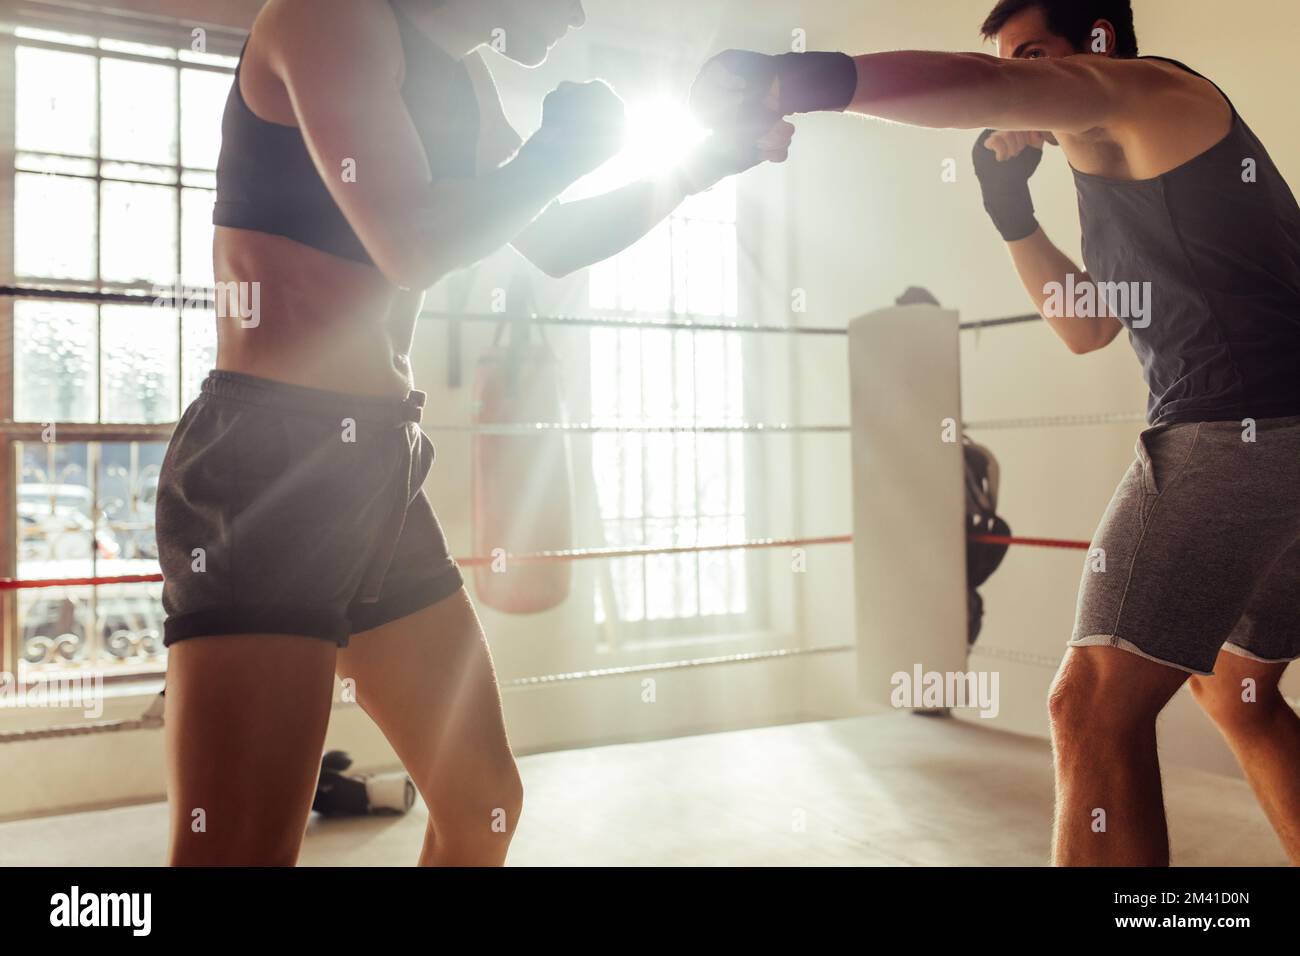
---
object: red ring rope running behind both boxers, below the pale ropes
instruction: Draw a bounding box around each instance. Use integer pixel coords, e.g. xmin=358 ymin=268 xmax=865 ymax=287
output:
xmin=0 ymin=535 xmax=1092 ymax=592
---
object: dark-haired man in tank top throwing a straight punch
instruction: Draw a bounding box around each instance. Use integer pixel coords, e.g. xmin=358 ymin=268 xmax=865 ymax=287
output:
xmin=693 ymin=0 xmax=1300 ymax=865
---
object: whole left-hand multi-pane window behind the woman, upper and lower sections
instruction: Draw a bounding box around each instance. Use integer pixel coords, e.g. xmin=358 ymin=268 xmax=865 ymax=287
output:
xmin=0 ymin=22 xmax=235 ymax=675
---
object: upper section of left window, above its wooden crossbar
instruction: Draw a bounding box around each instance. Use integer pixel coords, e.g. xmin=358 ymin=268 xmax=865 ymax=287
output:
xmin=14 ymin=31 xmax=234 ymax=424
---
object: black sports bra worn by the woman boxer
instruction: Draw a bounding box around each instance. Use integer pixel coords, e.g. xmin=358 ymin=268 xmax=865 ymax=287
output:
xmin=212 ymin=4 xmax=480 ymax=265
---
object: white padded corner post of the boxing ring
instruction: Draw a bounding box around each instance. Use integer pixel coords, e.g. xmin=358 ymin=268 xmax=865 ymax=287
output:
xmin=849 ymin=306 xmax=967 ymax=705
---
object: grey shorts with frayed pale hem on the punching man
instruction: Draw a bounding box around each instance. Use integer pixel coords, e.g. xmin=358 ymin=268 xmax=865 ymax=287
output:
xmin=1070 ymin=418 xmax=1300 ymax=674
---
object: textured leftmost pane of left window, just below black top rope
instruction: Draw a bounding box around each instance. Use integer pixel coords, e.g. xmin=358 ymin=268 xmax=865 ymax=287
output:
xmin=13 ymin=302 xmax=96 ymax=423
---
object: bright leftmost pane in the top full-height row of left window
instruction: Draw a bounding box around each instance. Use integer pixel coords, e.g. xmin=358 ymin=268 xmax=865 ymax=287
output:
xmin=14 ymin=47 xmax=96 ymax=156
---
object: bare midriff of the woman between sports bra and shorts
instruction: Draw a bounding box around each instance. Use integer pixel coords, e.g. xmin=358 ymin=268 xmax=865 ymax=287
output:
xmin=213 ymin=228 xmax=424 ymax=398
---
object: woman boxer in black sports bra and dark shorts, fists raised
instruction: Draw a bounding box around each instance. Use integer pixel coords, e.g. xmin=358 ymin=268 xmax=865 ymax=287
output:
xmin=157 ymin=0 xmax=793 ymax=865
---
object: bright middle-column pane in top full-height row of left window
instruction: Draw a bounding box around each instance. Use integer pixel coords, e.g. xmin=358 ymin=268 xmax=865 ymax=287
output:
xmin=101 ymin=59 xmax=176 ymax=165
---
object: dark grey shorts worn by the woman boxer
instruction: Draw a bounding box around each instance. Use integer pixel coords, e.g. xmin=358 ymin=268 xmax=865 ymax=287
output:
xmin=157 ymin=372 xmax=463 ymax=646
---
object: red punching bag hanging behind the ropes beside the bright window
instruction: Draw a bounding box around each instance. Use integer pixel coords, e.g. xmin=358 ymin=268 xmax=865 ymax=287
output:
xmin=472 ymin=320 xmax=573 ymax=614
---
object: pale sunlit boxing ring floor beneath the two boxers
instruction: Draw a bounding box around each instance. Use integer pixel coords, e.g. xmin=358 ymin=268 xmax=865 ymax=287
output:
xmin=0 ymin=714 xmax=1287 ymax=866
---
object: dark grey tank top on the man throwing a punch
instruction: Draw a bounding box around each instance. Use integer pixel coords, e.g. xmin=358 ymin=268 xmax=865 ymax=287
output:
xmin=1074 ymin=57 xmax=1300 ymax=425
